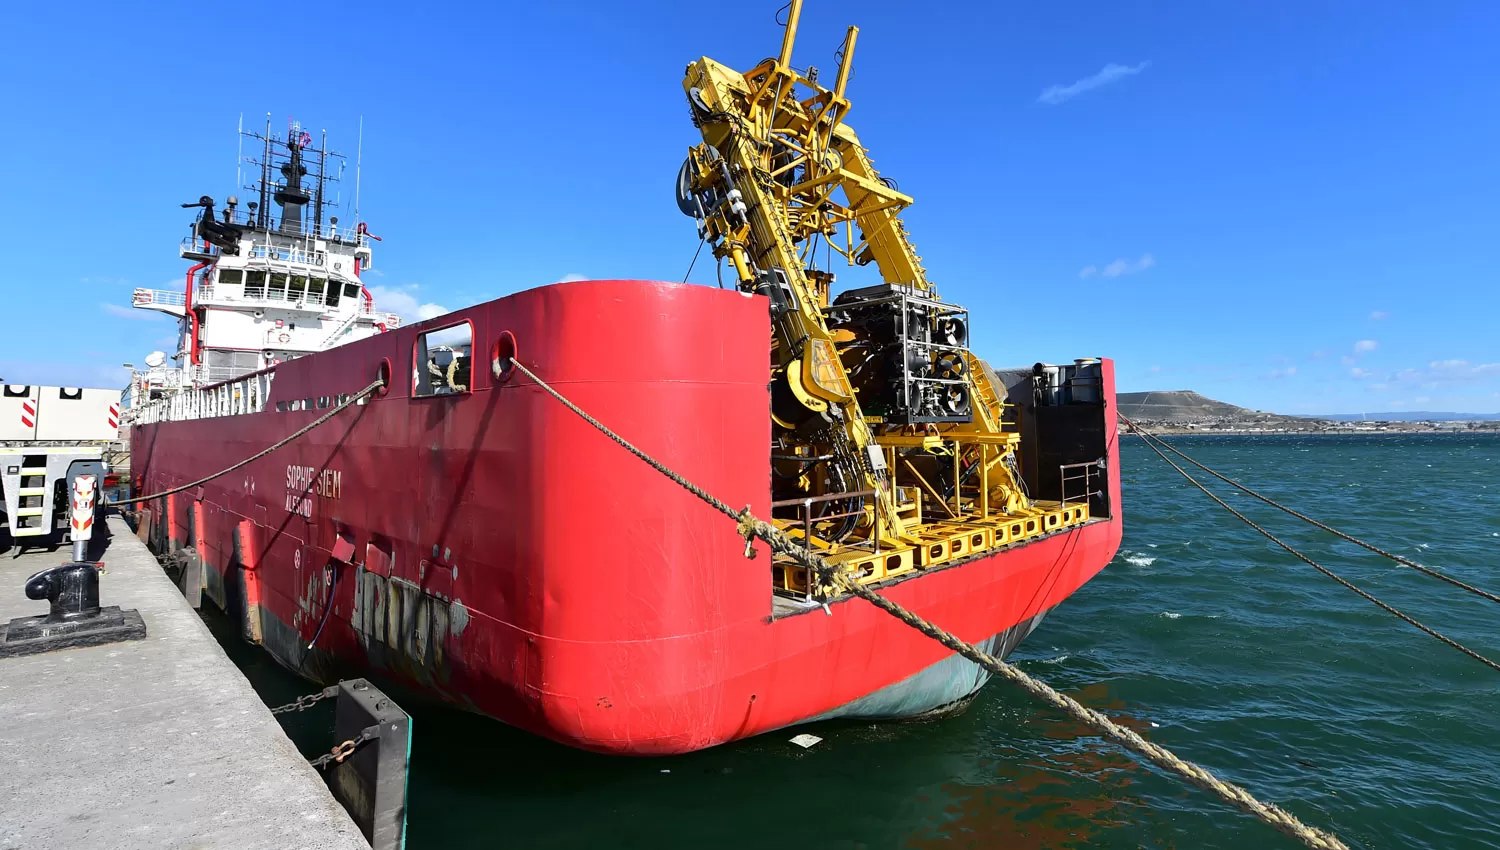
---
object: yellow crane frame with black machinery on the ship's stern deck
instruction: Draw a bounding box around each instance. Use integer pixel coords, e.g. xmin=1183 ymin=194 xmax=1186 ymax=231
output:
xmin=677 ymin=0 xmax=1088 ymax=595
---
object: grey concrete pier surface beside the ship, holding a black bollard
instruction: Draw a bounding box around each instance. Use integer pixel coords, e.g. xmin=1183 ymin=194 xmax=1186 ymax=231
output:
xmin=0 ymin=516 xmax=369 ymax=850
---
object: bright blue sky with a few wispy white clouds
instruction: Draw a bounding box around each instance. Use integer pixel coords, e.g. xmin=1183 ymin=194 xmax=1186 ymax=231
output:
xmin=0 ymin=0 xmax=1500 ymax=412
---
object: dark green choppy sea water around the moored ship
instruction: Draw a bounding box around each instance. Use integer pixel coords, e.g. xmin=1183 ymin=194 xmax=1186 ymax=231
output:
xmin=222 ymin=436 xmax=1500 ymax=850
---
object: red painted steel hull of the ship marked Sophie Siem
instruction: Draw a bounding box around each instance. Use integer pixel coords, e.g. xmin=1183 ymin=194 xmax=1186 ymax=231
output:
xmin=132 ymin=280 xmax=1121 ymax=754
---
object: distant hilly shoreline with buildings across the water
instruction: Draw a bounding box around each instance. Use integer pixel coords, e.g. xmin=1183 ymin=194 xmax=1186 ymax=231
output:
xmin=1116 ymin=390 xmax=1500 ymax=433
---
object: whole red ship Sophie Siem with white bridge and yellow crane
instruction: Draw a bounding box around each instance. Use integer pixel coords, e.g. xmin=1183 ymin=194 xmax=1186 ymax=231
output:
xmin=131 ymin=0 xmax=1122 ymax=756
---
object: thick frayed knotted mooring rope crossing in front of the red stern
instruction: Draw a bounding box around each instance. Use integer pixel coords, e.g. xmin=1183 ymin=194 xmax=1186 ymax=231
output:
xmin=510 ymin=358 xmax=1349 ymax=850
